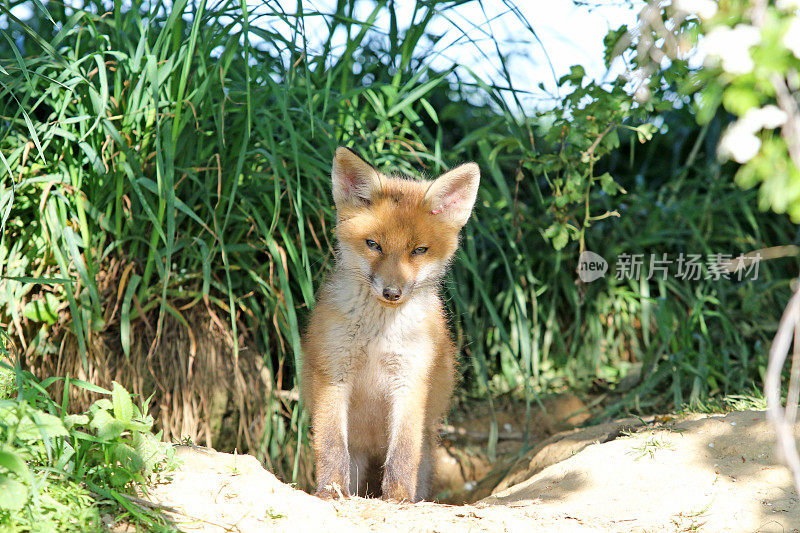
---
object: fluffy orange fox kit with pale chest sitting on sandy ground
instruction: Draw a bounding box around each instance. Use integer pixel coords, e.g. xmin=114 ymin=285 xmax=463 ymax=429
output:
xmin=303 ymin=148 xmax=480 ymax=501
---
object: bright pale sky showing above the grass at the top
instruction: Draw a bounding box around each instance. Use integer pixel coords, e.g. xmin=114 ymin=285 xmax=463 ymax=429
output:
xmin=282 ymin=0 xmax=644 ymax=107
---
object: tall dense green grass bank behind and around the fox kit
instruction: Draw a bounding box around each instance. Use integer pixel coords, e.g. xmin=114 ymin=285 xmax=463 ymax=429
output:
xmin=0 ymin=0 xmax=797 ymax=494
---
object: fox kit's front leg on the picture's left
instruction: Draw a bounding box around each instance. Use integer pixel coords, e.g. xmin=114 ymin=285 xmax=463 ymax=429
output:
xmin=311 ymin=383 xmax=350 ymax=498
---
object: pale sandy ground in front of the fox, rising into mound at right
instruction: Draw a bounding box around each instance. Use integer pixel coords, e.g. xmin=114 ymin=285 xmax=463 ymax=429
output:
xmin=148 ymin=411 xmax=800 ymax=533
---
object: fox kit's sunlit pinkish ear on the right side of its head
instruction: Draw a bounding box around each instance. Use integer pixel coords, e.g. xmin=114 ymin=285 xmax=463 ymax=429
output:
xmin=425 ymin=163 xmax=481 ymax=228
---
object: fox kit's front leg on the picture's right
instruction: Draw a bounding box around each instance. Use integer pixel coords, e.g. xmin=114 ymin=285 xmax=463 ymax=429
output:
xmin=381 ymin=378 xmax=427 ymax=501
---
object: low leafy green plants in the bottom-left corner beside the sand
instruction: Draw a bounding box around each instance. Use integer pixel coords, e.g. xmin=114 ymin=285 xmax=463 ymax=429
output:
xmin=0 ymin=338 xmax=173 ymax=531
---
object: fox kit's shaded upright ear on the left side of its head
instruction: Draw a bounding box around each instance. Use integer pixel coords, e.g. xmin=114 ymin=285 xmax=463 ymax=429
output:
xmin=331 ymin=146 xmax=381 ymax=209
